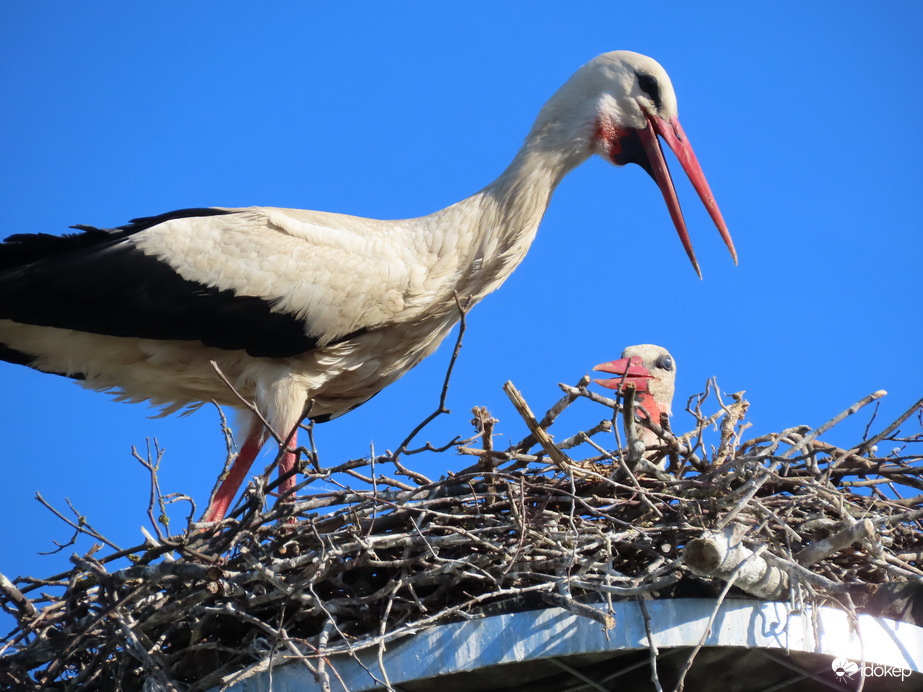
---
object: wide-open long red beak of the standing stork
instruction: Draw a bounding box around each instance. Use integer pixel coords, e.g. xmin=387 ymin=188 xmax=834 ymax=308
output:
xmin=638 ymin=114 xmax=737 ymax=279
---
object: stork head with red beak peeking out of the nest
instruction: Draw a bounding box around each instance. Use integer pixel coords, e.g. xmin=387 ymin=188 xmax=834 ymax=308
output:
xmin=593 ymin=344 xmax=676 ymax=423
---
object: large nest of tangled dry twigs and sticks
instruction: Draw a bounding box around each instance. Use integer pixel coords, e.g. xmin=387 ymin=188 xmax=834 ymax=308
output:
xmin=0 ymin=370 xmax=923 ymax=690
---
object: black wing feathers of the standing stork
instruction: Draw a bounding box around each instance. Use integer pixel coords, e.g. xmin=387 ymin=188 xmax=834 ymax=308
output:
xmin=0 ymin=209 xmax=317 ymax=362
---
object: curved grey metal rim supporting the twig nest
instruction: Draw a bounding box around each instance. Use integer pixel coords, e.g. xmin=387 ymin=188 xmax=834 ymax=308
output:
xmin=218 ymin=599 xmax=923 ymax=692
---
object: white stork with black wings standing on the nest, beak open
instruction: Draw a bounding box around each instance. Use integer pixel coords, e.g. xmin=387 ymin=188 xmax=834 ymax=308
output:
xmin=0 ymin=51 xmax=737 ymax=521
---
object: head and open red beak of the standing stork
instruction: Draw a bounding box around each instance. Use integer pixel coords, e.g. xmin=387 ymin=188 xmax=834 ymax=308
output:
xmin=533 ymin=51 xmax=737 ymax=278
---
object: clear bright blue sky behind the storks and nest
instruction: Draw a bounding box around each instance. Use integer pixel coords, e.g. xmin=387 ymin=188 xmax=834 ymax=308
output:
xmin=0 ymin=2 xmax=923 ymax=600
